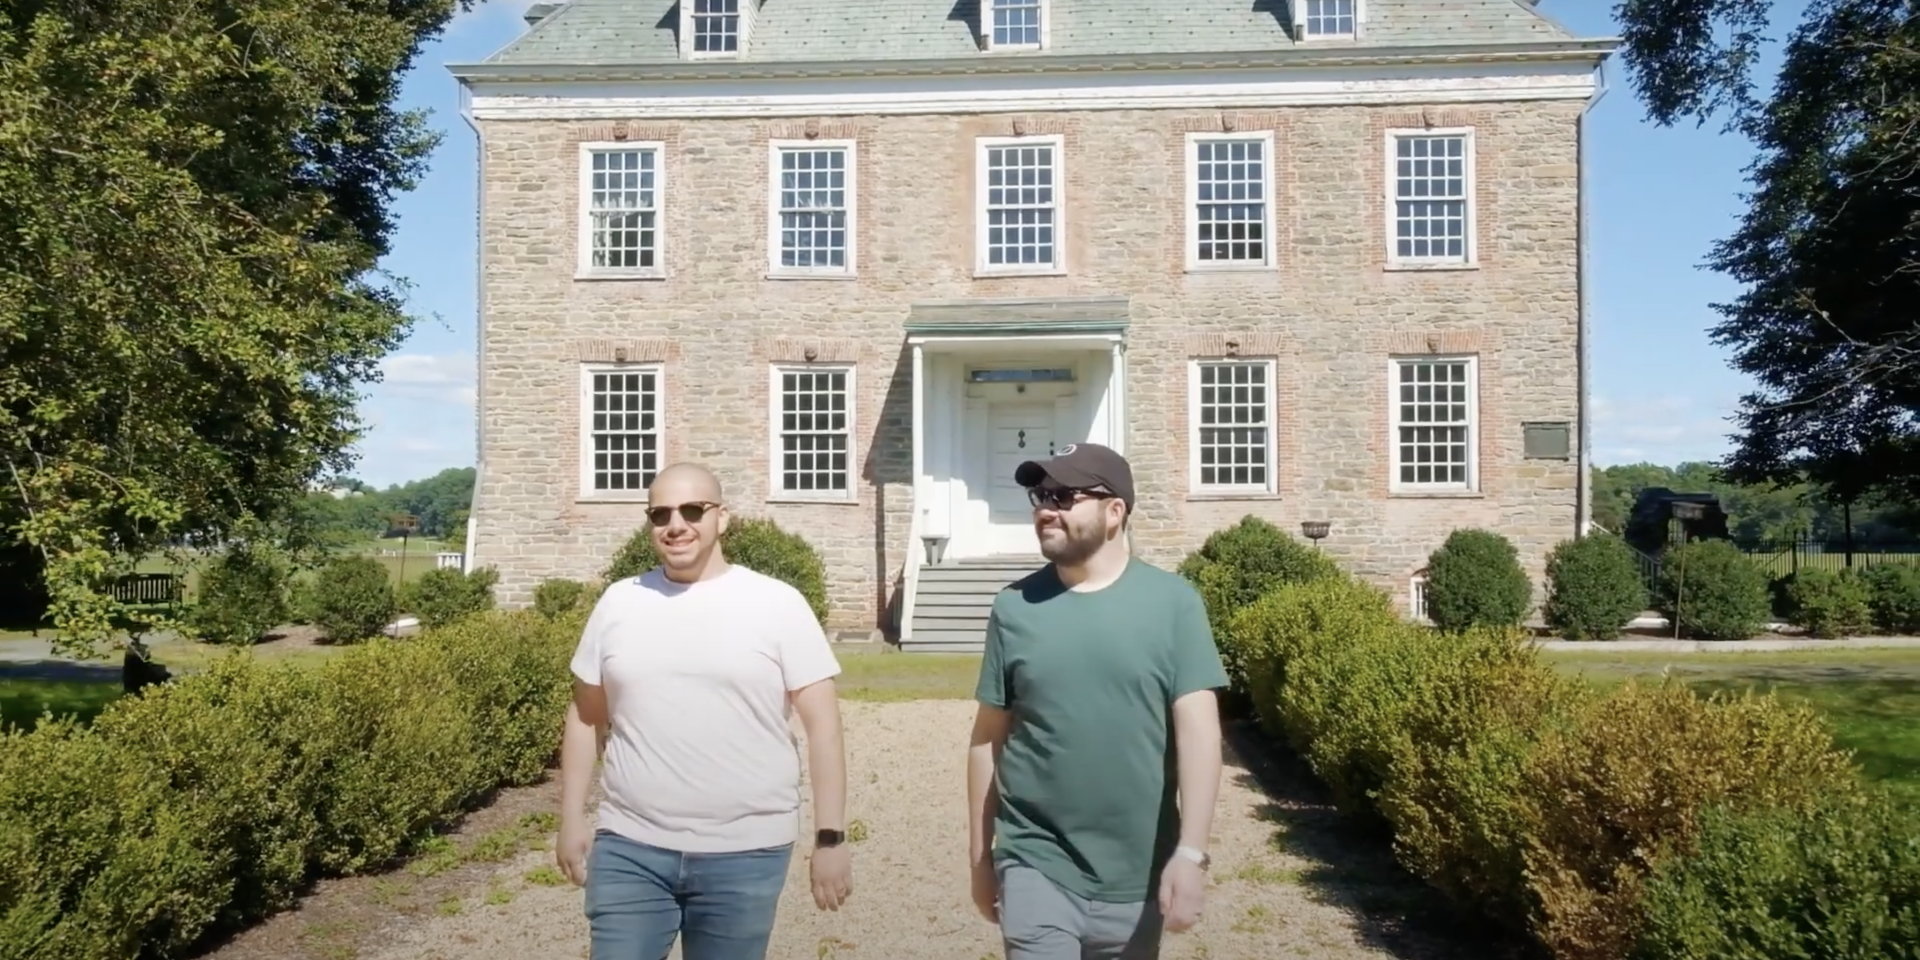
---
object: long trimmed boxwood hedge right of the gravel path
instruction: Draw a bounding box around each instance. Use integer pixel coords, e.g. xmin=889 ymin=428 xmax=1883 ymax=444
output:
xmin=1205 ymin=541 xmax=1896 ymax=960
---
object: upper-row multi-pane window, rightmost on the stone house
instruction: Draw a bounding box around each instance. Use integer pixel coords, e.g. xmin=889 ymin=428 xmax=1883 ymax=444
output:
xmin=1394 ymin=134 xmax=1469 ymax=261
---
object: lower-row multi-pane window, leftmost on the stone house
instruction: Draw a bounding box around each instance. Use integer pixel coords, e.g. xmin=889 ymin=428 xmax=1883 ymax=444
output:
xmin=582 ymin=367 xmax=660 ymax=495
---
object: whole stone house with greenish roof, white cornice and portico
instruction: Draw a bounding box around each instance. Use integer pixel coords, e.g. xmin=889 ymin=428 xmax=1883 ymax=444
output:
xmin=449 ymin=0 xmax=1615 ymax=649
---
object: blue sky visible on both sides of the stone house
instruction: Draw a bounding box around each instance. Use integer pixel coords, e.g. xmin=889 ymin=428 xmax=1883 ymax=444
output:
xmin=355 ymin=0 xmax=1753 ymax=486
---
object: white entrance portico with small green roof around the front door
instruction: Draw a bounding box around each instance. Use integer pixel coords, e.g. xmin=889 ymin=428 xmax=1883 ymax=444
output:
xmin=906 ymin=298 xmax=1127 ymax=564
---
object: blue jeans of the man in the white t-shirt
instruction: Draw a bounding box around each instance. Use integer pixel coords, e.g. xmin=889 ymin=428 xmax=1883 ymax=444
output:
xmin=586 ymin=829 xmax=793 ymax=960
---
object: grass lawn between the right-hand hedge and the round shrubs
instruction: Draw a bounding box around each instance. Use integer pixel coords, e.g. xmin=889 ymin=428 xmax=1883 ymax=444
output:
xmin=1544 ymin=649 xmax=1920 ymax=803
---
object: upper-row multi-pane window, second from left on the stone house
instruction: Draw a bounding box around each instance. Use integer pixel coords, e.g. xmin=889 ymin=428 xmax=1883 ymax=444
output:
xmin=774 ymin=146 xmax=852 ymax=273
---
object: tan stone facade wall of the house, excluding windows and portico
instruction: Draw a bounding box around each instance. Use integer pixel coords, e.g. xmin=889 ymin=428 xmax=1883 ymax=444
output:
xmin=472 ymin=102 xmax=1582 ymax=628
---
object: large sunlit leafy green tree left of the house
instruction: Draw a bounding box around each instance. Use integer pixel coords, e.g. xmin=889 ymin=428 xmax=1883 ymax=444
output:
xmin=0 ymin=0 xmax=468 ymax=649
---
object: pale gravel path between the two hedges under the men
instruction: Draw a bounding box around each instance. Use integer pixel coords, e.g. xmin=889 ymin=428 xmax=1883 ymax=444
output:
xmin=351 ymin=701 xmax=1488 ymax=960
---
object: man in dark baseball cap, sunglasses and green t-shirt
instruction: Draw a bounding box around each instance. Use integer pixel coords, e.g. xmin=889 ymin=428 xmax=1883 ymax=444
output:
xmin=968 ymin=444 xmax=1227 ymax=960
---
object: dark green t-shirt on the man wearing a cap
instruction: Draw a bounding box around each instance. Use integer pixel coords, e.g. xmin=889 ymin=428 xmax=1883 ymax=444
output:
xmin=973 ymin=559 xmax=1227 ymax=902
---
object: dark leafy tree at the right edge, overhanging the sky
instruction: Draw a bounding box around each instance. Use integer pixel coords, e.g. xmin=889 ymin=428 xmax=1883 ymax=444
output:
xmin=1615 ymin=0 xmax=1920 ymax=505
